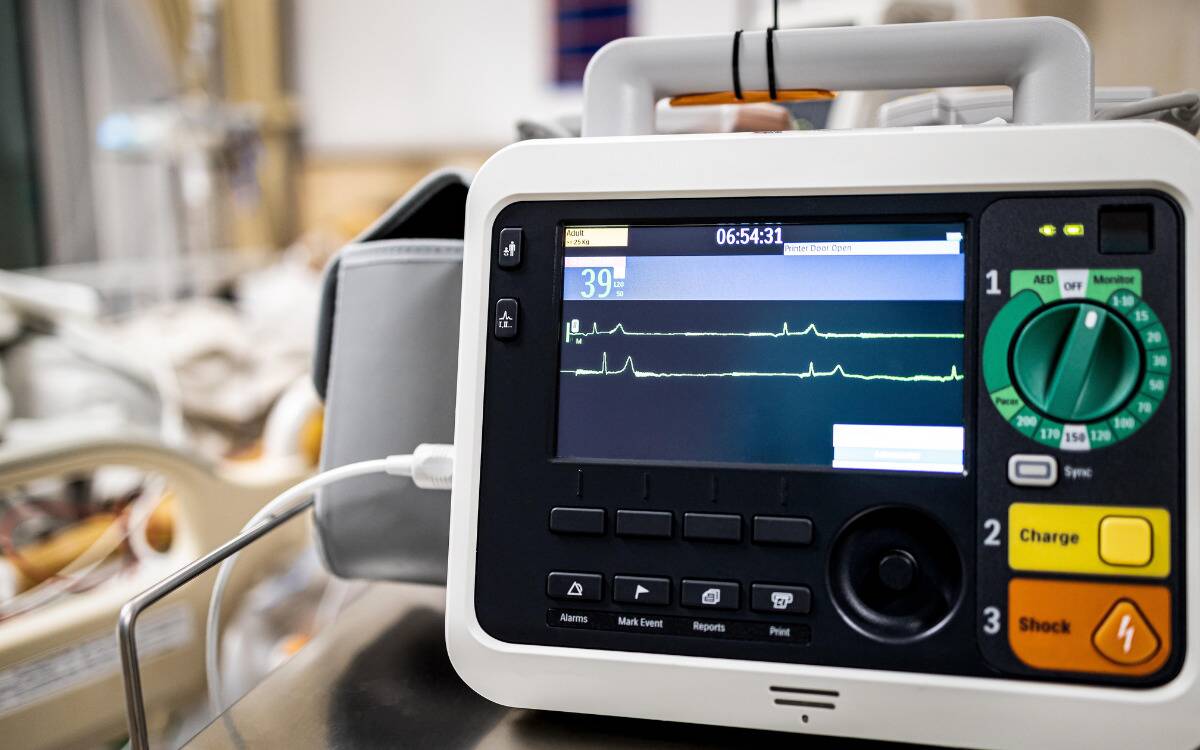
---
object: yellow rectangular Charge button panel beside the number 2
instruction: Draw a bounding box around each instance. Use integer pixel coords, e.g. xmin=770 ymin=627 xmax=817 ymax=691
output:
xmin=1008 ymin=503 xmax=1171 ymax=578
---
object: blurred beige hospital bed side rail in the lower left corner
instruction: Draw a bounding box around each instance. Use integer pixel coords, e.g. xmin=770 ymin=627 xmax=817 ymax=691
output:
xmin=0 ymin=438 xmax=308 ymax=750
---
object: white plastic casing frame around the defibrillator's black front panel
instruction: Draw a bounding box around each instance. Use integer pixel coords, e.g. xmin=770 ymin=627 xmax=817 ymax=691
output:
xmin=446 ymin=121 xmax=1200 ymax=749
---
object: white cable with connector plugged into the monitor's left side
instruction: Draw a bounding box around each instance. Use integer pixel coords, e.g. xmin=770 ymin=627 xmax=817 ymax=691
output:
xmin=204 ymin=443 xmax=454 ymax=716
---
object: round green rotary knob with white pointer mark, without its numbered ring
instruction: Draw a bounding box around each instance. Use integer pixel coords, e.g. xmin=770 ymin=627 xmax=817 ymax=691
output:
xmin=1012 ymin=302 xmax=1141 ymax=422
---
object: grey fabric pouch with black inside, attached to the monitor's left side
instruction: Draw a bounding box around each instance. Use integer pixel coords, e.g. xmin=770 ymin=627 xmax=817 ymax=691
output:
xmin=313 ymin=170 xmax=469 ymax=583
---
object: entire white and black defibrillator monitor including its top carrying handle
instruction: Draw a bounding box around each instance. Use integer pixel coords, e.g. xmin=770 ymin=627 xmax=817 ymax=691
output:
xmin=446 ymin=19 xmax=1200 ymax=749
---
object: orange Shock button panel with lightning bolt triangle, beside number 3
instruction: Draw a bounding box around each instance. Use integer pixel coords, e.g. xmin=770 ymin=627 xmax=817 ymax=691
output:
xmin=1008 ymin=578 xmax=1171 ymax=676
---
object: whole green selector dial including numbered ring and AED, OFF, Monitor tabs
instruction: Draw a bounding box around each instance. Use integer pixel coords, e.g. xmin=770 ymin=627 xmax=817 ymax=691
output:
xmin=983 ymin=269 xmax=1171 ymax=451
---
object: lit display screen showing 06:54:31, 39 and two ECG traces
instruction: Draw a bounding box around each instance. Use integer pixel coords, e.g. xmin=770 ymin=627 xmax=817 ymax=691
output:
xmin=557 ymin=222 xmax=966 ymax=474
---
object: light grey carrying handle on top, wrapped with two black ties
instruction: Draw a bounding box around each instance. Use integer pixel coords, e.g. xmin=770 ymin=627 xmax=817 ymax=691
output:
xmin=583 ymin=18 xmax=1093 ymax=137
